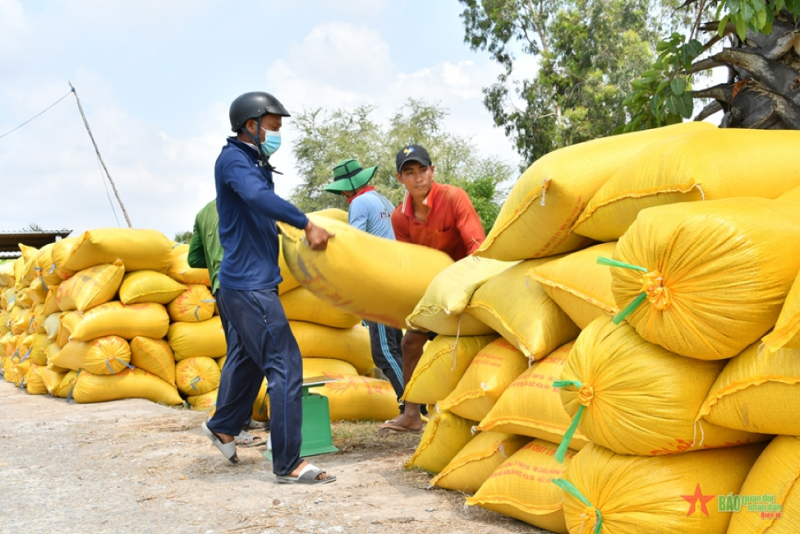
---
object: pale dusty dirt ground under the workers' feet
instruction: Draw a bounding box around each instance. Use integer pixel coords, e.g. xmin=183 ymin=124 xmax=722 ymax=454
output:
xmin=0 ymin=380 xmax=546 ymax=534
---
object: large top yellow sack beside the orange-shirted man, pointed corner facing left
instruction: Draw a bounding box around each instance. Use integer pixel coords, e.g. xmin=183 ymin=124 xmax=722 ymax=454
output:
xmin=475 ymin=122 xmax=713 ymax=261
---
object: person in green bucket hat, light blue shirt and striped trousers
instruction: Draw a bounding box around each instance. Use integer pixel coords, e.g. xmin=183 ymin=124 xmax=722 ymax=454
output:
xmin=325 ymin=159 xmax=403 ymax=402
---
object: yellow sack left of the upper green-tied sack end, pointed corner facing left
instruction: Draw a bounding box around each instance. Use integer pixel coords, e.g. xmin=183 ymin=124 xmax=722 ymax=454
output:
xmin=531 ymin=242 xmax=619 ymax=328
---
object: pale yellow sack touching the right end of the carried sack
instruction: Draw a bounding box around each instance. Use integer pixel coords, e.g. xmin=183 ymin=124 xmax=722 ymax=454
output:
xmin=406 ymin=256 xmax=515 ymax=336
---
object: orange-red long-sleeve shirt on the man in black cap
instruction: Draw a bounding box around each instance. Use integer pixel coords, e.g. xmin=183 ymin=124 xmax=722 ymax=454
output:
xmin=392 ymin=182 xmax=486 ymax=261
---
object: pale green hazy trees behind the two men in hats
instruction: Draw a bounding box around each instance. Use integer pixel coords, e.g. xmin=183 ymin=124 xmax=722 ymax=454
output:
xmin=291 ymin=99 xmax=513 ymax=231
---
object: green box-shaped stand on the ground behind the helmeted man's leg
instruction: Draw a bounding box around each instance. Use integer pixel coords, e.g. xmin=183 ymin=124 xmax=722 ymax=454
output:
xmin=264 ymin=376 xmax=339 ymax=461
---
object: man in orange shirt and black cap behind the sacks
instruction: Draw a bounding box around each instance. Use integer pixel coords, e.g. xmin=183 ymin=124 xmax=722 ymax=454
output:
xmin=381 ymin=145 xmax=486 ymax=432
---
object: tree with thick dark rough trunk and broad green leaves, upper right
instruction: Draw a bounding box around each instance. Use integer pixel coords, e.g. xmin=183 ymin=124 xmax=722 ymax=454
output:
xmin=624 ymin=0 xmax=800 ymax=131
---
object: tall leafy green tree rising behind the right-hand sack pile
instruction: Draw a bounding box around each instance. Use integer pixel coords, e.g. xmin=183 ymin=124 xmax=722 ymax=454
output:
xmin=459 ymin=0 xmax=677 ymax=164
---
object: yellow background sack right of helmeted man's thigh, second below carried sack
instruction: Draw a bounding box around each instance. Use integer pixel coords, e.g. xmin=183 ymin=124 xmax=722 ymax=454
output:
xmin=289 ymin=321 xmax=375 ymax=375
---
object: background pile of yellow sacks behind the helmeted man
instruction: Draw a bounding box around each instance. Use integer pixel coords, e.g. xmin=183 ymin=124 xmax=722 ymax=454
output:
xmin=0 ymin=210 xmax=398 ymax=426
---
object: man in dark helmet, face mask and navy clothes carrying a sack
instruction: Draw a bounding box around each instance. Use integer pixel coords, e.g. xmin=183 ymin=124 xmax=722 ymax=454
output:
xmin=203 ymin=92 xmax=336 ymax=484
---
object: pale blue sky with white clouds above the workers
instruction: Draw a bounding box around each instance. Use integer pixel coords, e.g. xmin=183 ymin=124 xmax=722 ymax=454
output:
xmin=0 ymin=0 xmax=535 ymax=237
